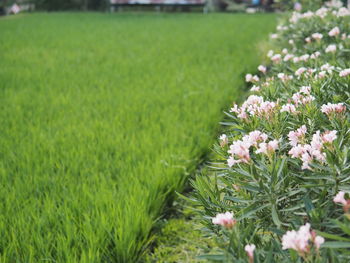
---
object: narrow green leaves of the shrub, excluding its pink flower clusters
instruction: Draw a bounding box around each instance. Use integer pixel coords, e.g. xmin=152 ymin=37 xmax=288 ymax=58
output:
xmin=189 ymin=4 xmax=350 ymax=262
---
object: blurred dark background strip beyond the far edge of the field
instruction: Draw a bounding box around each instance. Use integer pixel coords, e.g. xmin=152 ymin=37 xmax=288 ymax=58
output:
xmin=0 ymin=0 xmax=350 ymax=15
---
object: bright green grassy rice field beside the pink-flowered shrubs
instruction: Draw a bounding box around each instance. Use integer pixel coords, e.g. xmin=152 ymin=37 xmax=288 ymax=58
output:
xmin=0 ymin=13 xmax=275 ymax=263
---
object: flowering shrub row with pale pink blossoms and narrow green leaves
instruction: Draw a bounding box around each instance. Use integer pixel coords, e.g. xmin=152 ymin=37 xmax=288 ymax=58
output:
xmin=190 ymin=1 xmax=350 ymax=262
